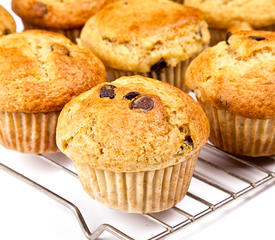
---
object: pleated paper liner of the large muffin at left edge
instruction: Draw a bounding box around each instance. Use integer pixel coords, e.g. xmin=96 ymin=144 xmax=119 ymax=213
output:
xmin=0 ymin=112 xmax=59 ymax=153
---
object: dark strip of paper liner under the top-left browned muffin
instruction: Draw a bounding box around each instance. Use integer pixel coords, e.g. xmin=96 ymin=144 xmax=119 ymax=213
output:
xmin=23 ymin=21 xmax=82 ymax=43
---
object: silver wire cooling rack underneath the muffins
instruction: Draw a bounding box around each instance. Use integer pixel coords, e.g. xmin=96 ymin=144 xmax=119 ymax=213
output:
xmin=0 ymin=144 xmax=275 ymax=240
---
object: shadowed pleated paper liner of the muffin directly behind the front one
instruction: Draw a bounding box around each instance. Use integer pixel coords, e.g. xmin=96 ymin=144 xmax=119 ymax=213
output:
xmin=106 ymin=58 xmax=193 ymax=92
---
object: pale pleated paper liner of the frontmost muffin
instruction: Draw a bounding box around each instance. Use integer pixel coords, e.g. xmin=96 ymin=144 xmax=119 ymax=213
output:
xmin=75 ymin=153 xmax=198 ymax=213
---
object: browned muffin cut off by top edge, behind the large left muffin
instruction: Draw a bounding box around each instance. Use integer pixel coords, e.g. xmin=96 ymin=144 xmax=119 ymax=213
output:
xmin=12 ymin=0 xmax=107 ymax=41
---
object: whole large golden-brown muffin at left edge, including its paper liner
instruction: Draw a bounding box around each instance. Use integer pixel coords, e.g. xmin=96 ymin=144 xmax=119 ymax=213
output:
xmin=0 ymin=30 xmax=105 ymax=153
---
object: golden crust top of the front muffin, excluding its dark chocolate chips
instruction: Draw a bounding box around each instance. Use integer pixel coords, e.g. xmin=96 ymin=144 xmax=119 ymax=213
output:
xmin=57 ymin=76 xmax=209 ymax=172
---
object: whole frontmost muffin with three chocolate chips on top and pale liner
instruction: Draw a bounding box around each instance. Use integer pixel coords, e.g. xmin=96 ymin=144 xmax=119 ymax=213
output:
xmin=57 ymin=76 xmax=209 ymax=213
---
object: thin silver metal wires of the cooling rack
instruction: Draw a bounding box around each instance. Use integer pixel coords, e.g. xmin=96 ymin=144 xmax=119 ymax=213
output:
xmin=0 ymin=144 xmax=275 ymax=240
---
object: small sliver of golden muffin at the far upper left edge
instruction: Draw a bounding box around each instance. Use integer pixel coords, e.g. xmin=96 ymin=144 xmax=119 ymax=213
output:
xmin=0 ymin=5 xmax=16 ymax=37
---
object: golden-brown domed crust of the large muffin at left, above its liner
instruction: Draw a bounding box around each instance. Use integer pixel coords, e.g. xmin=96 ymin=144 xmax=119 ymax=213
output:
xmin=0 ymin=30 xmax=105 ymax=113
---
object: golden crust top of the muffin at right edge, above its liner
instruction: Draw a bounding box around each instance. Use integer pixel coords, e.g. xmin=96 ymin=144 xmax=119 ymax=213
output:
xmin=186 ymin=31 xmax=275 ymax=119
